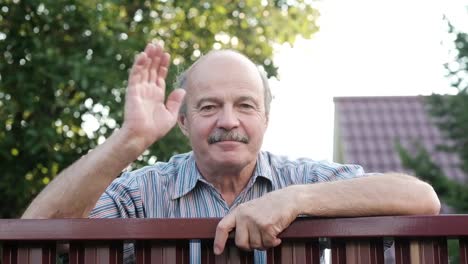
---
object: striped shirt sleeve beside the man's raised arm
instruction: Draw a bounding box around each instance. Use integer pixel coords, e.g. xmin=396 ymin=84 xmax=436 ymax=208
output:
xmin=89 ymin=172 xmax=145 ymax=218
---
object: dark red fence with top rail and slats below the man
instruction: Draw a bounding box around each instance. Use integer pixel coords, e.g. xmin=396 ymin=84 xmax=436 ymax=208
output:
xmin=0 ymin=215 xmax=468 ymax=264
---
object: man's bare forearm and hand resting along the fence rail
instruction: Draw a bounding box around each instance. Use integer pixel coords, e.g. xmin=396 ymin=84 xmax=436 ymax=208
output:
xmin=214 ymin=173 xmax=440 ymax=254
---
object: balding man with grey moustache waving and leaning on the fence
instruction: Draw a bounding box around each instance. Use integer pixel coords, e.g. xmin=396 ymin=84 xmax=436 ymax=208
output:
xmin=23 ymin=44 xmax=440 ymax=260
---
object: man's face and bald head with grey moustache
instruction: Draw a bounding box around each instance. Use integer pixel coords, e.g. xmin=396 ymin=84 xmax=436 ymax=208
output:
xmin=179 ymin=53 xmax=267 ymax=173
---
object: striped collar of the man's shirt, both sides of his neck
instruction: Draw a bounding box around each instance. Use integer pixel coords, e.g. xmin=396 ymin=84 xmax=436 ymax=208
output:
xmin=172 ymin=152 xmax=273 ymax=200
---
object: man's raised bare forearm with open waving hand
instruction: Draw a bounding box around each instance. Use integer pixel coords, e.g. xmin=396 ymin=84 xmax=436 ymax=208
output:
xmin=22 ymin=44 xmax=185 ymax=218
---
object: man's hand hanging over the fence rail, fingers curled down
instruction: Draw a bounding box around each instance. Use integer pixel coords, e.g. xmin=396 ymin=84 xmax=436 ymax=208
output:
xmin=214 ymin=186 xmax=299 ymax=255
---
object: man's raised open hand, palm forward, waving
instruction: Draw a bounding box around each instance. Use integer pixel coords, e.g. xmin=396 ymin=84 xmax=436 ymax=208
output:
xmin=122 ymin=44 xmax=185 ymax=151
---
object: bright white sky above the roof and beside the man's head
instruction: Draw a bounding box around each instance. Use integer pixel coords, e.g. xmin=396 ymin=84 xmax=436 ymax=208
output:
xmin=262 ymin=0 xmax=468 ymax=160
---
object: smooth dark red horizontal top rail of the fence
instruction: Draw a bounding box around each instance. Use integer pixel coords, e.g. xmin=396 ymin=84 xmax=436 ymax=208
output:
xmin=0 ymin=215 xmax=468 ymax=241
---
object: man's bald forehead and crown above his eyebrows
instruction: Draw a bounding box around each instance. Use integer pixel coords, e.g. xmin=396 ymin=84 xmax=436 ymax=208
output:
xmin=187 ymin=51 xmax=263 ymax=93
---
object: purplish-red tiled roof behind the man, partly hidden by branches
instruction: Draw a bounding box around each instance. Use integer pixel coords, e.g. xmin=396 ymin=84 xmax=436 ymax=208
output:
xmin=334 ymin=96 xmax=464 ymax=180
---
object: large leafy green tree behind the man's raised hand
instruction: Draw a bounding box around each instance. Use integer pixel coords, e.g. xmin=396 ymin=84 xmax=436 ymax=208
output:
xmin=0 ymin=0 xmax=318 ymax=218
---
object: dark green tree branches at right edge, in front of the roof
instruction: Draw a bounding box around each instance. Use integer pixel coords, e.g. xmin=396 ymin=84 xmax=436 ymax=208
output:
xmin=397 ymin=16 xmax=468 ymax=213
